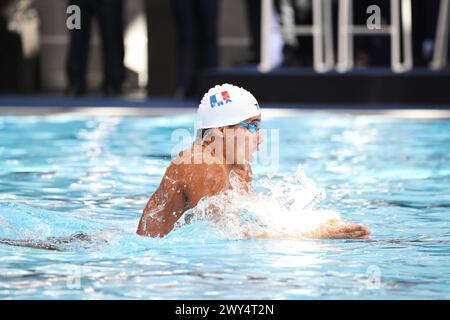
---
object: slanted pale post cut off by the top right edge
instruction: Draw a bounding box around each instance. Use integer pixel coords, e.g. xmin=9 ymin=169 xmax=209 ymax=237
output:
xmin=430 ymin=0 xmax=450 ymax=70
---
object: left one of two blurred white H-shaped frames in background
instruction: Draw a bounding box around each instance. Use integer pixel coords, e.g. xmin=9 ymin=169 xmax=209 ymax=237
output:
xmin=259 ymin=0 xmax=334 ymax=72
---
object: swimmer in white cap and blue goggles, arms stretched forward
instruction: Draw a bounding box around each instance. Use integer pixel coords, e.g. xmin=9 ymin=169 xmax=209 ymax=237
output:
xmin=137 ymin=84 xmax=370 ymax=239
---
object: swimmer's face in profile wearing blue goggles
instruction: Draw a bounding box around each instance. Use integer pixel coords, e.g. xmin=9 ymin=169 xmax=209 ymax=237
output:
xmin=224 ymin=116 xmax=262 ymax=164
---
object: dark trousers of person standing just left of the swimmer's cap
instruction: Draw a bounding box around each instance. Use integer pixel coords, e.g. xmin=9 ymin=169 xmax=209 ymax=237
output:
xmin=173 ymin=0 xmax=219 ymax=96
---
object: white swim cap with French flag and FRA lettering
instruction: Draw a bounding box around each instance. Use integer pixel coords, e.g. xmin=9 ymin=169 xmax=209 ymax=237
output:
xmin=197 ymin=83 xmax=261 ymax=129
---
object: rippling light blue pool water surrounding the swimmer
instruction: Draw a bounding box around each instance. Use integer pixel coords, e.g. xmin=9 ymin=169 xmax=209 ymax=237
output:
xmin=0 ymin=113 xmax=450 ymax=299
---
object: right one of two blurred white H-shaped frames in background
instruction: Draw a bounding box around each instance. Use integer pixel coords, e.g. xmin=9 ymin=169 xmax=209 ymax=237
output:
xmin=337 ymin=0 xmax=413 ymax=72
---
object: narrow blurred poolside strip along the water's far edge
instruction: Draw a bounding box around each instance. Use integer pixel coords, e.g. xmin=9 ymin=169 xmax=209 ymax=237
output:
xmin=0 ymin=96 xmax=450 ymax=119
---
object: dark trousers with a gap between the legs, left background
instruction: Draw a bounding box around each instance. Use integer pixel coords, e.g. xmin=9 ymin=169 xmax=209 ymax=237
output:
xmin=66 ymin=0 xmax=125 ymax=90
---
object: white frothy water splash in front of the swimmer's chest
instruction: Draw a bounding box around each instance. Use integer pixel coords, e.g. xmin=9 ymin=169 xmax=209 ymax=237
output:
xmin=172 ymin=165 xmax=340 ymax=239
